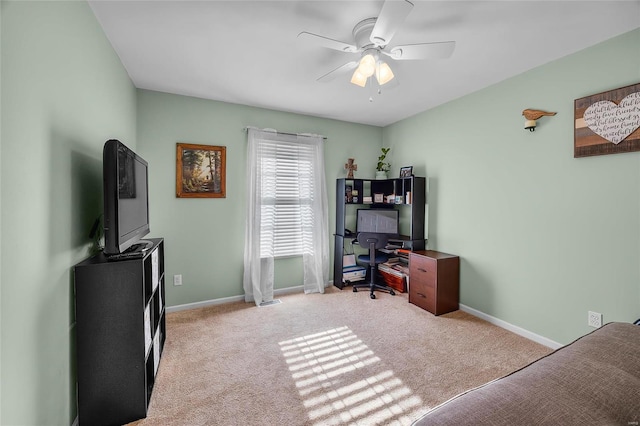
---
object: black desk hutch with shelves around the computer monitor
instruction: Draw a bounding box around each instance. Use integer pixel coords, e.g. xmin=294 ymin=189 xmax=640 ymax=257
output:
xmin=333 ymin=176 xmax=426 ymax=289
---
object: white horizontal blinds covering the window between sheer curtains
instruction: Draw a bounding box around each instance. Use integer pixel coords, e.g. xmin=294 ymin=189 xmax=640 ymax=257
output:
xmin=258 ymin=135 xmax=315 ymax=257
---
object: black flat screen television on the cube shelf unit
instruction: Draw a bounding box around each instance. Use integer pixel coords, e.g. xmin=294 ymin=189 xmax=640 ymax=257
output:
xmin=103 ymin=139 xmax=150 ymax=256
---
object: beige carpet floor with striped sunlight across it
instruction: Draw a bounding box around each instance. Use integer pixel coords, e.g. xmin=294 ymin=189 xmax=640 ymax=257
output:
xmin=133 ymin=287 xmax=550 ymax=426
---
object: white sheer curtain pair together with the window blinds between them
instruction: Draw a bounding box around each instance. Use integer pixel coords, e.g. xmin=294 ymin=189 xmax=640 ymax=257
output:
xmin=243 ymin=128 xmax=329 ymax=305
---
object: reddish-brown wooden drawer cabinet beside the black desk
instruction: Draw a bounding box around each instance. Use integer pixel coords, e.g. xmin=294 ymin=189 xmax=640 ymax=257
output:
xmin=409 ymin=250 xmax=460 ymax=315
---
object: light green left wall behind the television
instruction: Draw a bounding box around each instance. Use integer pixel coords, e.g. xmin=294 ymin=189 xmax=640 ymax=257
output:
xmin=0 ymin=1 xmax=136 ymax=425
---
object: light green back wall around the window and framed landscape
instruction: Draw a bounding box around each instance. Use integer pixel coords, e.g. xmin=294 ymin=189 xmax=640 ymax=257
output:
xmin=138 ymin=90 xmax=382 ymax=305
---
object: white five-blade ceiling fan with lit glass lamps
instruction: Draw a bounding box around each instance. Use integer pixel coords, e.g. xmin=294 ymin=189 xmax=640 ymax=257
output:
xmin=298 ymin=0 xmax=456 ymax=87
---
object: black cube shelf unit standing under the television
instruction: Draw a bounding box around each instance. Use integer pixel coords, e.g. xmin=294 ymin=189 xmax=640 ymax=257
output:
xmin=74 ymin=238 xmax=166 ymax=426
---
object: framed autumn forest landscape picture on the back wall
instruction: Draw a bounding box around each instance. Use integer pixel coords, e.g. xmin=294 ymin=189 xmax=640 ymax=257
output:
xmin=176 ymin=143 xmax=227 ymax=198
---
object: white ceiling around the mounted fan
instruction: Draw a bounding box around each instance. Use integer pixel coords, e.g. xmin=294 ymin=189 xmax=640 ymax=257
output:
xmin=89 ymin=0 xmax=640 ymax=126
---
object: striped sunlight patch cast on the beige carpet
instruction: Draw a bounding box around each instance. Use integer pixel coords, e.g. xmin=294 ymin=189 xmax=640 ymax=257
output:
xmin=279 ymin=326 xmax=422 ymax=425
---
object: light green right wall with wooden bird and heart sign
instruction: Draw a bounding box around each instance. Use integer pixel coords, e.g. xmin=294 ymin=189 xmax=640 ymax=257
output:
xmin=384 ymin=30 xmax=640 ymax=343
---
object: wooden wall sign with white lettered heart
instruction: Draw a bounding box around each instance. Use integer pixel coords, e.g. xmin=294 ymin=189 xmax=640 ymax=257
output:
xmin=573 ymin=83 xmax=640 ymax=158
